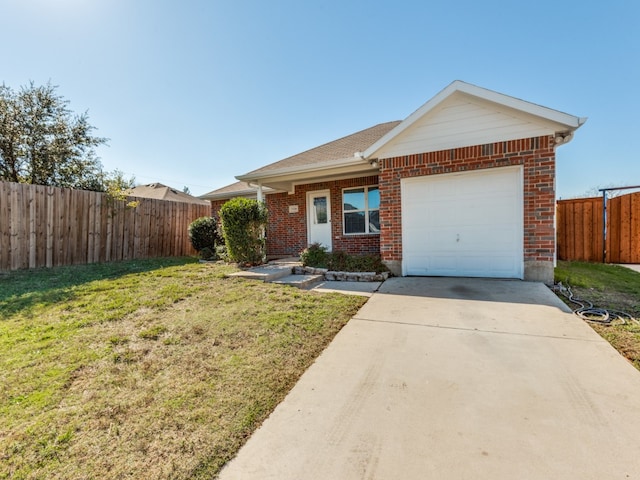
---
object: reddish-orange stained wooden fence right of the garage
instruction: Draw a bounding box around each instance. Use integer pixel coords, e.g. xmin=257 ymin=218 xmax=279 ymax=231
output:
xmin=556 ymin=192 xmax=640 ymax=263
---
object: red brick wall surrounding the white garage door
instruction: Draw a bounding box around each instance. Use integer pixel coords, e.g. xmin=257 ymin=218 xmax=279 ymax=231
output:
xmin=380 ymin=136 xmax=555 ymax=268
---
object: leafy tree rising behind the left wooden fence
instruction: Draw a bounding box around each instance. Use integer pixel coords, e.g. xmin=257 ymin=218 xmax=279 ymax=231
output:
xmin=0 ymin=82 xmax=110 ymax=191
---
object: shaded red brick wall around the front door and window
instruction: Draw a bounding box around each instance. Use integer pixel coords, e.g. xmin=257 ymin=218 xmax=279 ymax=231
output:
xmin=265 ymin=176 xmax=380 ymax=257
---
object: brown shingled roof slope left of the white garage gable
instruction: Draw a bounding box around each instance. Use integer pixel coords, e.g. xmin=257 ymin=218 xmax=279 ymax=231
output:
xmin=245 ymin=120 xmax=400 ymax=175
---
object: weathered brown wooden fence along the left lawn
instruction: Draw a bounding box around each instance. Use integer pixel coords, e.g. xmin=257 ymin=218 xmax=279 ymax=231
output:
xmin=0 ymin=182 xmax=211 ymax=271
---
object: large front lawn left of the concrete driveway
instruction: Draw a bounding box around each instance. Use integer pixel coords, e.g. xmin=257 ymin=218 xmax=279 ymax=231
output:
xmin=0 ymin=258 xmax=364 ymax=479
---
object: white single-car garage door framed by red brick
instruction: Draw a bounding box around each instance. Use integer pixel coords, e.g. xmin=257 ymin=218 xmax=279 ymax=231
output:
xmin=401 ymin=167 xmax=524 ymax=278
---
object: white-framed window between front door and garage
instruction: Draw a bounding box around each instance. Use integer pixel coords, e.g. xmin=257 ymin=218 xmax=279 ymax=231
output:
xmin=342 ymin=187 xmax=380 ymax=234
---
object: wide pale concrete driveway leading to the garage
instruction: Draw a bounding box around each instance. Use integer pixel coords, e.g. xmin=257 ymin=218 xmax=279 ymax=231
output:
xmin=220 ymin=278 xmax=640 ymax=480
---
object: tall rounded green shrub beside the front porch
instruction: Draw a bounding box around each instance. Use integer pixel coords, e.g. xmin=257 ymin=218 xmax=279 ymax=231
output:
xmin=220 ymin=198 xmax=267 ymax=265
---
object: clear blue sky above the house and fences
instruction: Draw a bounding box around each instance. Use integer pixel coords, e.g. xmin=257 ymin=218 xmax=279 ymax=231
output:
xmin=0 ymin=0 xmax=640 ymax=198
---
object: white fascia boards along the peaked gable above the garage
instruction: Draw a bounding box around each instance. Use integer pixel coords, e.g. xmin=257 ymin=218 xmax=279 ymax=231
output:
xmin=363 ymin=80 xmax=587 ymax=159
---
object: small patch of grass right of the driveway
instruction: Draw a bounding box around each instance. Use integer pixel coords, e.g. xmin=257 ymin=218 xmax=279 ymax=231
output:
xmin=555 ymin=262 xmax=640 ymax=370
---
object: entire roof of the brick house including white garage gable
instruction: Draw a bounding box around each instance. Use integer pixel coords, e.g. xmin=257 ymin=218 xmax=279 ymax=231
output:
xmin=224 ymin=80 xmax=586 ymax=193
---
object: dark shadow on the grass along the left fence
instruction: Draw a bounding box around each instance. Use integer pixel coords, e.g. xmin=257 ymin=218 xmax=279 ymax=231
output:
xmin=0 ymin=257 xmax=197 ymax=321
